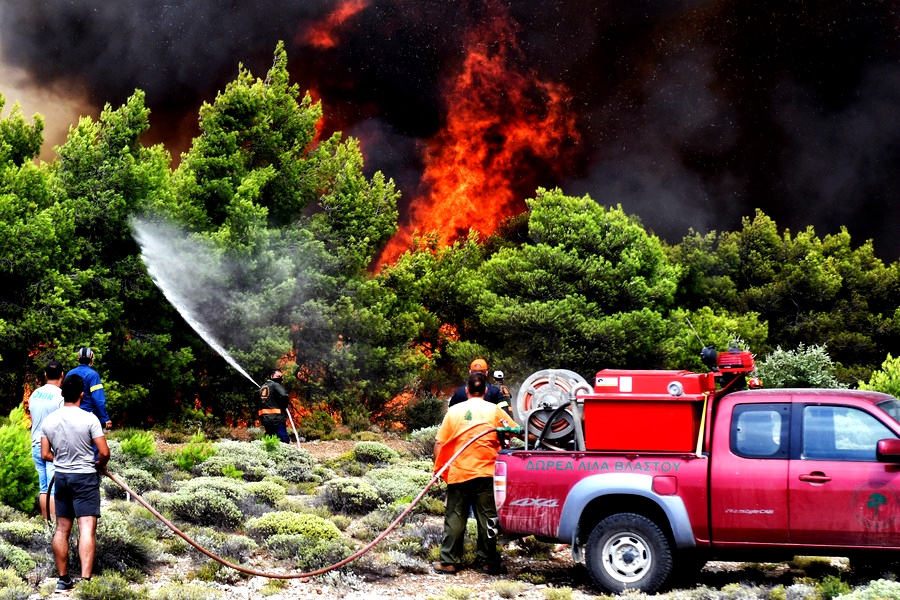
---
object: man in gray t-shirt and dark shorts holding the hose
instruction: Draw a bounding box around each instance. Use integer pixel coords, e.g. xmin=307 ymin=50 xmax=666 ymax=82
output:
xmin=41 ymin=375 xmax=109 ymax=590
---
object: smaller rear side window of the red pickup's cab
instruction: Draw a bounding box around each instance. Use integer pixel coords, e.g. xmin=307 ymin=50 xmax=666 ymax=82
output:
xmin=731 ymin=404 xmax=790 ymax=459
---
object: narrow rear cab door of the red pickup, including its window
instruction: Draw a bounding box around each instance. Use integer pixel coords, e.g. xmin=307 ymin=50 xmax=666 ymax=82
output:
xmin=710 ymin=402 xmax=791 ymax=543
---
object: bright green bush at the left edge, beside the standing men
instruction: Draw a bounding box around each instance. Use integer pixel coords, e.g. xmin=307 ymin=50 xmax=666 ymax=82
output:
xmin=0 ymin=404 xmax=40 ymax=512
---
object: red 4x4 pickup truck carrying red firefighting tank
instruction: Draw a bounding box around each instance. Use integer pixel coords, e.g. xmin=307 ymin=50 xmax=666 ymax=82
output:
xmin=494 ymin=371 xmax=900 ymax=593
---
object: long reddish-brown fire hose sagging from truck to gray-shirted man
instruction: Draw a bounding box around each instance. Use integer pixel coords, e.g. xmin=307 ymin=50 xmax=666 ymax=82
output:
xmin=96 ymin=427 xmax=521 ymax=579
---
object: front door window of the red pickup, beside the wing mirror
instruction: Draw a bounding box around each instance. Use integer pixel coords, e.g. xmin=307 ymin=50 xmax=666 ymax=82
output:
xmin=802 ymin=405 xmax=897 ymax=462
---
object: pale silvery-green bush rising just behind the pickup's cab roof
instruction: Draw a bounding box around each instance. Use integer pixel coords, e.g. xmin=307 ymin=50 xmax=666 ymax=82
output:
xmin=756 ymin=344 xmax=846 ymax=388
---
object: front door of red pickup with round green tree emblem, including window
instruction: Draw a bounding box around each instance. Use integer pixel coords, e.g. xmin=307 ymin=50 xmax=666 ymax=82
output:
xmin=789 ymin=404 xmax=900 ymax=546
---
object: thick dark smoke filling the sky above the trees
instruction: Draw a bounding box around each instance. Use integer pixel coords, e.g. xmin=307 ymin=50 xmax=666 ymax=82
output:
xmin=0 ymin=0 xmax=900 ymax=255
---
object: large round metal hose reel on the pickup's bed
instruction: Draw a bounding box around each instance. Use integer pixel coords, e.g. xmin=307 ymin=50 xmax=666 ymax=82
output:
xmin=513 ymin=369 xmax=593 ymax=450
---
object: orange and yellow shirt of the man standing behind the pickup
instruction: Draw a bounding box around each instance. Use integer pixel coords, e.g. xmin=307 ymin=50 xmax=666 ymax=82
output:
xmin=434 ymin=398 xmax=516 ymax=483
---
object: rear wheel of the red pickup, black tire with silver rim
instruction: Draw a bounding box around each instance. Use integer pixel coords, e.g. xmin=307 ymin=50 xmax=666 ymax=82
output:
xmin=585 ymin=513 xmax=672 ymax=594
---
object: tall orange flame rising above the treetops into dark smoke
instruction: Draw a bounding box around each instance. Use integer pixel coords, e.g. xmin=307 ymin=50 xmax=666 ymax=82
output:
xmin=378 ymin=1 xmax=577 ymax=264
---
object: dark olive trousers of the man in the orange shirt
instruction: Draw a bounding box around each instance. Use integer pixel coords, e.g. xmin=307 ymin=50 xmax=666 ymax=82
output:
xmin=441 ymin=477 xmax=500 ymax=567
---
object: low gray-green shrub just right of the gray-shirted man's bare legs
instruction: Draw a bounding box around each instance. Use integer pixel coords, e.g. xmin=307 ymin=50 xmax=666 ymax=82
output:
xmin=93 ymin=510 xmax=154 ymax=573
